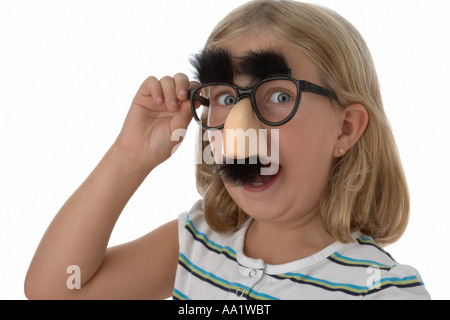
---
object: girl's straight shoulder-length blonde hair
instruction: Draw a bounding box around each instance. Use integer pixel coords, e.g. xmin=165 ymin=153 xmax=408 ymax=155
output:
xmin=196 ymin=0 xmax=409 ymax=245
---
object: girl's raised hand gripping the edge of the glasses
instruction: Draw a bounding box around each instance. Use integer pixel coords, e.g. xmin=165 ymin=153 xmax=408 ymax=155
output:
xmin=115 ymin=73 xmax=198 ymax=170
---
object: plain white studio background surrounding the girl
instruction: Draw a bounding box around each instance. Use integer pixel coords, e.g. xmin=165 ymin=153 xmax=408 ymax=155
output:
xmin=0 ymin=0 xmax=450 ymax=299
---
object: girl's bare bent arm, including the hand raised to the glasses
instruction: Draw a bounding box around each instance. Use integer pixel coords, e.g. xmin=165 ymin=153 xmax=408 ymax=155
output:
xmin=25 ymin=74 xmax=191 ymax=299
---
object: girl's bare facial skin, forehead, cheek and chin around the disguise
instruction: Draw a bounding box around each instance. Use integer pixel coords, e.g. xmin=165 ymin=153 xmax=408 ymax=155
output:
xmin=215 ymin=37 xmax=340 ymax=222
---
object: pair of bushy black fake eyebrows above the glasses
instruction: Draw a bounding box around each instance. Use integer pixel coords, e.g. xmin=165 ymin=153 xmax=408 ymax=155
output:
xmin=191 ymin=49 xmax=290 ymax=83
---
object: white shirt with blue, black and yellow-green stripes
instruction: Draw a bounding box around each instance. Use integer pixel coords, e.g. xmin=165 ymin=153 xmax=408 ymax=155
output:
xmin=173 ymin=202 xmax=430 ymax=300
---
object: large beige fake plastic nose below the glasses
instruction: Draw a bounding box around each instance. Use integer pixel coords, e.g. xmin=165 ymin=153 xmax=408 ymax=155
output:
xmin=223 ymin=98 xmax=267 ymax=159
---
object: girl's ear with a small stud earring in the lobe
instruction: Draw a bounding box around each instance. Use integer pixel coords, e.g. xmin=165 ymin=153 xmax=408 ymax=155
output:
xmin=334 ymin=103 xmax=369 ymax=157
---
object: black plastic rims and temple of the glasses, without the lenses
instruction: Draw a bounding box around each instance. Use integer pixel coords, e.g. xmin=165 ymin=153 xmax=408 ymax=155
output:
xmin=189 ymin=76 xmax=337 ymax=130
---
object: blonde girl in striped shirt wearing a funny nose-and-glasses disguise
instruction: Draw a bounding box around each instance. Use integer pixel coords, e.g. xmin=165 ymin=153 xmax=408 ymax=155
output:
xmin=25 ymin=0 xmax=429 ymax=299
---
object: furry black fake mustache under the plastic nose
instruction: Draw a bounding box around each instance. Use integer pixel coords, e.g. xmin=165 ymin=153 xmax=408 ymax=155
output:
xmin=217 ymin=156 xmax=272 ymax=187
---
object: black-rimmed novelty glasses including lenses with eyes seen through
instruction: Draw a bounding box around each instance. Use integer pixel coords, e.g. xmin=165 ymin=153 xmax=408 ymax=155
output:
xmin=189 ymin=76 xmax=336 ymax=130
